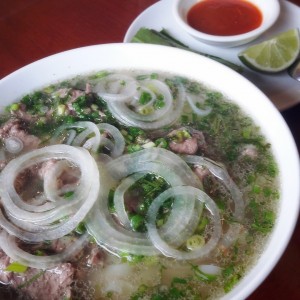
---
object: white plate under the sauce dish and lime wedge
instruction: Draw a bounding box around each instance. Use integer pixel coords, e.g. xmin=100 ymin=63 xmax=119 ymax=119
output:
xmin=124 ymin=0 xmax=300 ymax=110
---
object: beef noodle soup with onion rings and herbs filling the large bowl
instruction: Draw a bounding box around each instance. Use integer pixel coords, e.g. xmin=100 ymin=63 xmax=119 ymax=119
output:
xmin=0 ymin=70 xmax=279 ymax=300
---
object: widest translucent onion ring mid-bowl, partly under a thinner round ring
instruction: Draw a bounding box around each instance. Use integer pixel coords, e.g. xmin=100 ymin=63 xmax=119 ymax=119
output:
xmin=87 ymin=148 xmax=201 ymax=255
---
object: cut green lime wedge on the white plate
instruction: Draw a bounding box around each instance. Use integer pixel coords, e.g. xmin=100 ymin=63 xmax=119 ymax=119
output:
xmin=238 ymin=29 xmax=300 ymax=73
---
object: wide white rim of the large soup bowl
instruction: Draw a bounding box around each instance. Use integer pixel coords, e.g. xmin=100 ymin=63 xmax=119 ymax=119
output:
xmin=0 ymin=44 xmax=300 ymax=300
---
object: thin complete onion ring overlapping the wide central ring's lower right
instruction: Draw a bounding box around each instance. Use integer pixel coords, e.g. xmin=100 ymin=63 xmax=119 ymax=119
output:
xmin=146 ymin=186 xmax=222 ymax=260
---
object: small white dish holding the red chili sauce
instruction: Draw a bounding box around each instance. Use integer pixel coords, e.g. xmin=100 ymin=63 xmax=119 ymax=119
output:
xmin=172 ymin=0 xmax=280 ymax=47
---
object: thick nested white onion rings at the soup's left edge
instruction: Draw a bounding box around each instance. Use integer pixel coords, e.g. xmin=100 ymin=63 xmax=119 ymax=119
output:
xmin=0 ymin=145 xmax=100 ymax=242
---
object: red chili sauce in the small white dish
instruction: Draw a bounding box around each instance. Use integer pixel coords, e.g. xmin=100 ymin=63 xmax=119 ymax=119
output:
xmin=187 ymin=0 xmax=263 ymax=36
